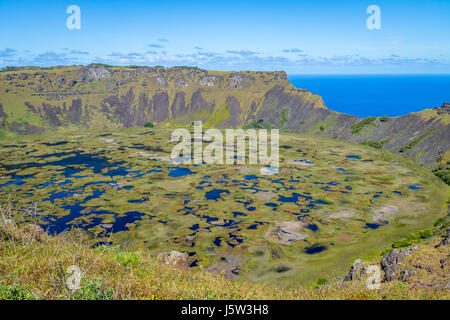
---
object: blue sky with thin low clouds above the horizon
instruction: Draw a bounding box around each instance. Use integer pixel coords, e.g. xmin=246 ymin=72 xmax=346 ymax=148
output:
xmin=0 ymin=0 xmax=450 ymax=74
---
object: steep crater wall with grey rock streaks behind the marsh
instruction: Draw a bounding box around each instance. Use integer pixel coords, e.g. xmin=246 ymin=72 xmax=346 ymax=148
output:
xmin=0 ymin=65 xmax=450 ymax=167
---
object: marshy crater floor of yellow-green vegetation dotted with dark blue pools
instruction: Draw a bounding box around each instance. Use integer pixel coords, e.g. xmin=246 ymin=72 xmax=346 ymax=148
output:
xmin=0 ymin=125 xmax=450 ymax=286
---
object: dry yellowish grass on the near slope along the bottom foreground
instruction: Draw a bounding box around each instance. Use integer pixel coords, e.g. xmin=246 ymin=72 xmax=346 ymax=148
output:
xmin=0 ymin=209 xmax=448 ymax=300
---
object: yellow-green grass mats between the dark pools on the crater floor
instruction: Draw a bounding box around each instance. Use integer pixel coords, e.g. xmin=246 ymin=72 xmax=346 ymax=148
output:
xmin=0 ymin=128 xmax=448 ymax=287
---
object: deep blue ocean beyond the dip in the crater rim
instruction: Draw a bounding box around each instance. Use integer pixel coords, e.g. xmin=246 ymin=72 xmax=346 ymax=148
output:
xmin=288 ymin=75 xmax=450 ymax=117
